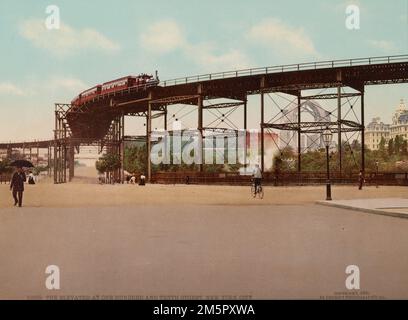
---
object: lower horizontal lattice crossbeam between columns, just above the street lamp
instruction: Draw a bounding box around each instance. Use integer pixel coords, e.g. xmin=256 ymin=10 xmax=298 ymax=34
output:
xmin=262 ymin=120 xmax=364 ymax=133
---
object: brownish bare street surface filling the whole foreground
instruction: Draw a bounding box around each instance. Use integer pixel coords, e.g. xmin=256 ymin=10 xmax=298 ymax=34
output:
xmin=0 ymin=204 xmax=408 ymax=299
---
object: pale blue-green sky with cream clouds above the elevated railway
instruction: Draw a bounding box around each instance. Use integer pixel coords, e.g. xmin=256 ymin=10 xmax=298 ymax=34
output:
xmin=0 ymin=0 xmax=408 ymax=142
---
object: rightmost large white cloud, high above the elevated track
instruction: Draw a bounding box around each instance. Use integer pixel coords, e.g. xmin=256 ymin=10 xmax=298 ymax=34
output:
xmin=247 ymin=19 xmax=319 ymax=57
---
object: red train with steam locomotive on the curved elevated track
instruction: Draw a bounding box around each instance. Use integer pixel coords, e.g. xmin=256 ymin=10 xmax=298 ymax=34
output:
xmin=71 ymin=71 xmax=160 ymax=106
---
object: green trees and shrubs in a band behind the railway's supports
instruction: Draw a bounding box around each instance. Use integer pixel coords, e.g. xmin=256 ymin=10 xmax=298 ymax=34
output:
xmin=120 ymin=136 xmax=408 ymax=174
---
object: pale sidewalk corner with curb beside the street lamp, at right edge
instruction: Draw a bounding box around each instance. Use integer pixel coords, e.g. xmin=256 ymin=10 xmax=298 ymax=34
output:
xmin=317 ymin=198 xmax=408 ymax=219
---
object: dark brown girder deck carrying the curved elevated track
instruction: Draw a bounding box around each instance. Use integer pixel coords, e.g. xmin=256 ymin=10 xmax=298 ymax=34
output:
xmin=61 ymin=56 xmax=408 ymax=141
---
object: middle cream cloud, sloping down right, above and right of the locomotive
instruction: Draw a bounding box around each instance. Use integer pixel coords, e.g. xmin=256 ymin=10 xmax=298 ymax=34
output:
xmin=140 ymin=20 xmax=250 ymax=72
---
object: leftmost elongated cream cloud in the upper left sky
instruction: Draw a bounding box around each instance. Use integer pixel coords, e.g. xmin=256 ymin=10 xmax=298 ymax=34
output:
xmin=20 ymin=19 xmax=120 ymax=57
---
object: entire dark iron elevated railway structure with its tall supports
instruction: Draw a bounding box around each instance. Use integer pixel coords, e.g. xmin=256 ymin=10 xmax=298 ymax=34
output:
xmin=2 ymin=55 xmax=408 ymax=183
